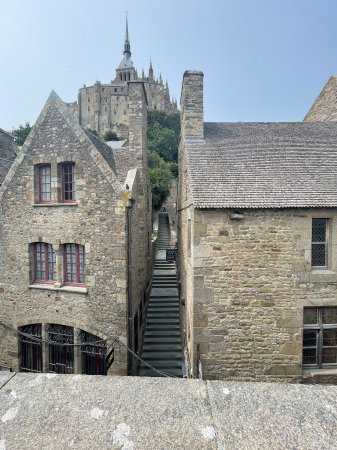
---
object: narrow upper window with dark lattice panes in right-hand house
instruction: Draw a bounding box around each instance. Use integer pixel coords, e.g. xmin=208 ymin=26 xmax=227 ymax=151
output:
xmin=311 ymin=219 xmax=328 ymax=267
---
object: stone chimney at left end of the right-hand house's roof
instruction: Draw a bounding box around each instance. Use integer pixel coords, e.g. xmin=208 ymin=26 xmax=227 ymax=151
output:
xmin=180 ymin=70 xmax=204 ymax=139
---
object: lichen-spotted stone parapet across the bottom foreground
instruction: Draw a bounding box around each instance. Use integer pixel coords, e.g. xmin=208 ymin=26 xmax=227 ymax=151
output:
xmin=0 ymin=373 xmax=337 ymax=450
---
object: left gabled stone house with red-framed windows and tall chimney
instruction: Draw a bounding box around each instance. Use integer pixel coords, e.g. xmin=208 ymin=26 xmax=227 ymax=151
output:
xmin=0 ymin=81 xmax=151 ymax=374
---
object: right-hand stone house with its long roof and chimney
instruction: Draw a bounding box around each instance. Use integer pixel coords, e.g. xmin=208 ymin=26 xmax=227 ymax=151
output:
xmin=178 ymin=71 xmax=337 ymax=381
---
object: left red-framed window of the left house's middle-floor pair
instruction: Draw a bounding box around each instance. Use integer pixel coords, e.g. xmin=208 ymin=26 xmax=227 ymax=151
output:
xmin=34 ymin=242 xmax=56 ymax=283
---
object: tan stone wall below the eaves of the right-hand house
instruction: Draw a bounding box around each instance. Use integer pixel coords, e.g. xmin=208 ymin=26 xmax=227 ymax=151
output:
xmin=189 ymin=210 xmax=337 ymax=381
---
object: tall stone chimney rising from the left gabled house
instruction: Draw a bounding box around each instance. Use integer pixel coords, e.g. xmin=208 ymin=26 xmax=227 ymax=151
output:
xmin=128 ymin=81 xmax=147 ymax=183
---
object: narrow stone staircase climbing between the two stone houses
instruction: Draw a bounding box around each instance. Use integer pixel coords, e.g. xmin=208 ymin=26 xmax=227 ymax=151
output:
xmin=139 ymin=213 xmax=184 ymax=377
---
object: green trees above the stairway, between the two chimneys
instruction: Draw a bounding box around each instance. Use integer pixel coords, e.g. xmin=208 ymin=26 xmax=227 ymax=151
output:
xmin=147 ymin=110 xmax=180 ymax=209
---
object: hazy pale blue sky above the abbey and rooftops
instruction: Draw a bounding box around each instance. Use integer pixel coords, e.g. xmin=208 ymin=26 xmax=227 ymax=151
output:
xmin=0 ymin=0 xmax=337 ymax=131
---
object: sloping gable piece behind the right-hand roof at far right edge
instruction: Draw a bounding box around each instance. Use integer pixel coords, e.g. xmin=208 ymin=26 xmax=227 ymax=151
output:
xmin=304 ymin=76 xmax=337 ymax=122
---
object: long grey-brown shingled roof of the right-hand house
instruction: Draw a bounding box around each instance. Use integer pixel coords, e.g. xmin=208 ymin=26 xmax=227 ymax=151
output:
xmin=185 ymin=122 xmax=337 ymax=208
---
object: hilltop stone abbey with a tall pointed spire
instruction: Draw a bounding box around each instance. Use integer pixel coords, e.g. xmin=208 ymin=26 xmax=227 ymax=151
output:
xmin=78 ymin=16 xmax=177 ymax=138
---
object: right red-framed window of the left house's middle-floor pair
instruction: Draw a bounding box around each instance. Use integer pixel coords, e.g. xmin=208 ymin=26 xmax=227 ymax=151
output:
xmin=64 ymin=244 xmax=85 ymax=284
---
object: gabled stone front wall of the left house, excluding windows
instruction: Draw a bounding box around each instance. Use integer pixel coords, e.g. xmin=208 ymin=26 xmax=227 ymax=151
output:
xmin=0 ymin=106 xmax=127 ymax=374
